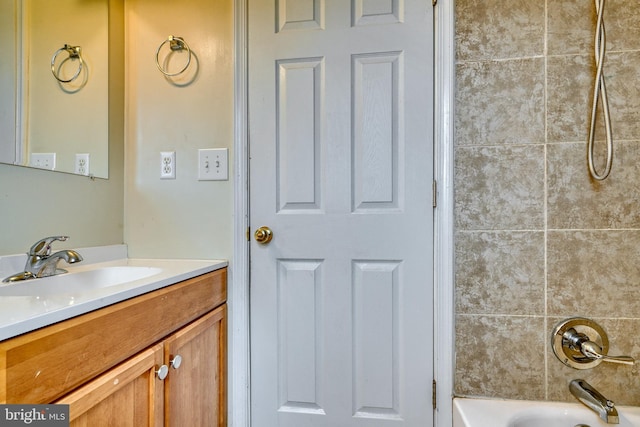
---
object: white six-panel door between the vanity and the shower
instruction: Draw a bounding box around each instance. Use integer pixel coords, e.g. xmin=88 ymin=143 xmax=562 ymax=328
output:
xmin=248 ymin=0 xmax=433 ymax=427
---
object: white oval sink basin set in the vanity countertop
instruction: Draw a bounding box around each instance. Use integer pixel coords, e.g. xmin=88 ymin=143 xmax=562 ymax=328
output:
xmin=0 ymin=266 xmax=162 ymax=296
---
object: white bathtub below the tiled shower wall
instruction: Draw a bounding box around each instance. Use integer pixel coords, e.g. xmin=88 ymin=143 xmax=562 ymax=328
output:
xmin=453 ymin=398 xmax=640 ymax=427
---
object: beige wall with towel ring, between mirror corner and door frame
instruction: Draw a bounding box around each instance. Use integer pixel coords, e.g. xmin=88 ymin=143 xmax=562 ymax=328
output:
xmin=125 ymin=0 xmax=234 ymax=259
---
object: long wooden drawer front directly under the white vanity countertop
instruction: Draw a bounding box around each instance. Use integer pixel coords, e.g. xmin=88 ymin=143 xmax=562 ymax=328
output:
xmin=0 ymin=269 xmax=227 ymax=404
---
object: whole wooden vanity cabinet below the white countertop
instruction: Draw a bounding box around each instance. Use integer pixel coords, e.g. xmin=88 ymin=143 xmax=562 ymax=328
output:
xmin=0 ymin=269 xmax=227 ymax=427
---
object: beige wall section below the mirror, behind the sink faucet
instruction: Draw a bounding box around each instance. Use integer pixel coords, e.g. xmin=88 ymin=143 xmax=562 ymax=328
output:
xmin=0 ymin=162 xmax=123 ymax=255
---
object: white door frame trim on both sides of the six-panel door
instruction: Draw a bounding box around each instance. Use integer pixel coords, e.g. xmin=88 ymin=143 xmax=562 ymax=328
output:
xmin=227 ymin=0 xmax=455 ymax=427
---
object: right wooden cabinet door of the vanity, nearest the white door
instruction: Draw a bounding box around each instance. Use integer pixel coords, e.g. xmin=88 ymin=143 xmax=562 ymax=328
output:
xmin=164 ymin=304 xmax=227 ymax=427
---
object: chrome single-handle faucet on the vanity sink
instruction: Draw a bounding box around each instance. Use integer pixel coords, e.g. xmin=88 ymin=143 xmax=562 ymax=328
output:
xmin=3 ymin=236 xmax=82 ymax=282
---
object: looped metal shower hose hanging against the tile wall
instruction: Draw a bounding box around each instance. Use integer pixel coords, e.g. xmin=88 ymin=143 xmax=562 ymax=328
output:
xmin=587 ymin=0 xmax=613 ymax=181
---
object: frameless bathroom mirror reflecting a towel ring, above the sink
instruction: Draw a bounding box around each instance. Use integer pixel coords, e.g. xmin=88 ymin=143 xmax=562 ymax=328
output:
xmin=0 ymin=0 xmax=114 ymax=178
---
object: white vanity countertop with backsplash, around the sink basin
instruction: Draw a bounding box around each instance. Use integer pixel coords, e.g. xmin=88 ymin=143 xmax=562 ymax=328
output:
xmin=0 ymin=245 xmax=228 ymax=340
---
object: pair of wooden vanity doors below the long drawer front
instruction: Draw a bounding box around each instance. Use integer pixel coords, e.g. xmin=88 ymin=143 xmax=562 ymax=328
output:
xmin=55 ymin=304 xmax=227 ymax=427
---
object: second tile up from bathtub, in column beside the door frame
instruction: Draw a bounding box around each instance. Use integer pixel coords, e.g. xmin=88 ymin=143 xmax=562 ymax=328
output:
xmin=455 ymin=231 xmax=545 ymax=315
